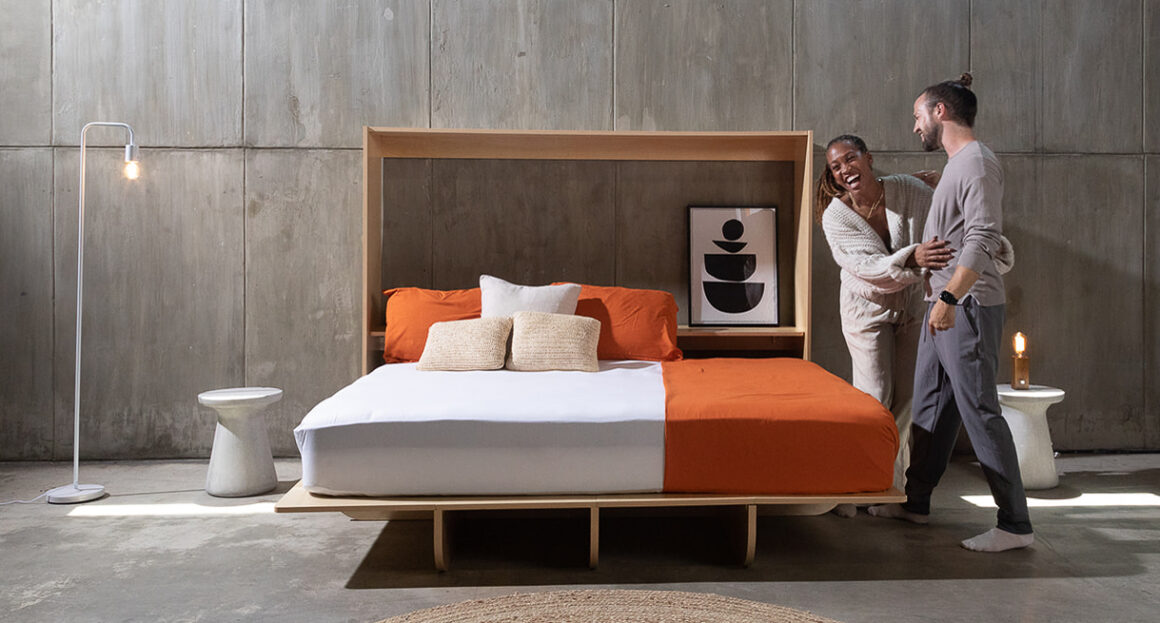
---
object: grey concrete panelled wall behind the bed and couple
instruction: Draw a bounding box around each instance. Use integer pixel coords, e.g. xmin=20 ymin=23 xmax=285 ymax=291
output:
xmin=0 ymin=0 xmax=1160 ymax=459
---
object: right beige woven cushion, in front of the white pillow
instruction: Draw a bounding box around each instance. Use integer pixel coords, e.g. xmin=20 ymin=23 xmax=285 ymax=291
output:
xmin=507 ymin=311 xmax=600 ymax=372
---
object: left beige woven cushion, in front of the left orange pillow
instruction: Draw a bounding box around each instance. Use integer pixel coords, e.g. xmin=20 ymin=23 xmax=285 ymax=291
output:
xmin=418 ymin=318 xmax=512 ymax=370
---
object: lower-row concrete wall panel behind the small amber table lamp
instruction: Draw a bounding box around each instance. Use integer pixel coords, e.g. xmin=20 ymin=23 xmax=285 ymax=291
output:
xmin=1000 ymin=155 xmax=1145 ymax=450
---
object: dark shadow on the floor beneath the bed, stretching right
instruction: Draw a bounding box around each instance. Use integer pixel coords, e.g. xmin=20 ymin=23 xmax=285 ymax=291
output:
xmin=347 ymin=489 xmax=1160 ymax=588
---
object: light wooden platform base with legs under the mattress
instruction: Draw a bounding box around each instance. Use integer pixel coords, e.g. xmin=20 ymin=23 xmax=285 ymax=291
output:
xmin=274 ymin=483 xmax=906 ymax=571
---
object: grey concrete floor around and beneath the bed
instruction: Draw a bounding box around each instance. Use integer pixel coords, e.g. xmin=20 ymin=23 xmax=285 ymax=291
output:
xmin=0 ymin=454 xmax=1160 ymax=623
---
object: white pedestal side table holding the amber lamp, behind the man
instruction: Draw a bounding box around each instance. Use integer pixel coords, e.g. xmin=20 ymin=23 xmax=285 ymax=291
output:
xmin=998 ymin=384 xmax=1065 ymax=490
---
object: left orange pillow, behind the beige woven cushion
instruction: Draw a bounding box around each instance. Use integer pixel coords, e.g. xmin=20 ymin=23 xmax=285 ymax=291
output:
xmin=383 ymin=288 xmax=480 ymax=363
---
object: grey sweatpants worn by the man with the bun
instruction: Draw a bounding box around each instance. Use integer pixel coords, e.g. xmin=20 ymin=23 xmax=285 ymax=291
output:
xmin=902 ymin=296 xmax=1031 ymax=535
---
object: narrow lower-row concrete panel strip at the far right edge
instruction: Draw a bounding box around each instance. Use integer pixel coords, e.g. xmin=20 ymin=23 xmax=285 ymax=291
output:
xmin=1141 ymin=155 xmax=1160 ymax=448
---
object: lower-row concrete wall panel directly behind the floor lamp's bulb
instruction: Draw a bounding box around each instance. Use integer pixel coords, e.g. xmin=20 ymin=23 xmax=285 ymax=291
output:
xmin=53 ymin=148 xmax=246 ymax=458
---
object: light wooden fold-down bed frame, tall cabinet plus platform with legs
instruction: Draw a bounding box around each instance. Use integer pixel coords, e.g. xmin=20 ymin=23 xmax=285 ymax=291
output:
xmin=275 ymin=128 xmax=905 ymax=571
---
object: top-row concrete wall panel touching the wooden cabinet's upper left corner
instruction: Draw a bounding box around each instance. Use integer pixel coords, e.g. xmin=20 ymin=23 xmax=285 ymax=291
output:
xmin=246 ymin=0 xmax=430 ymax=147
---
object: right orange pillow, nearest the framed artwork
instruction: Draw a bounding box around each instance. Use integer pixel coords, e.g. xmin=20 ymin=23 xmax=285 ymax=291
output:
xmin=559 ymin=285 xmax=682 ymax=361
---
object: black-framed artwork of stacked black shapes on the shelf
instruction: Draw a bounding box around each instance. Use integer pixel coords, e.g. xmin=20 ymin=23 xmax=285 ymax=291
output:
xmin=689 ymin=205 xmax=777 ymax=326
